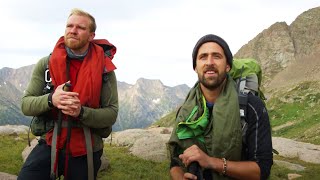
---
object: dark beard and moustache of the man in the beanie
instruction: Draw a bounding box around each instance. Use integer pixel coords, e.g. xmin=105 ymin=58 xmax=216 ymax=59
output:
xmin=198 ymin=67 xmax=227 ymax=90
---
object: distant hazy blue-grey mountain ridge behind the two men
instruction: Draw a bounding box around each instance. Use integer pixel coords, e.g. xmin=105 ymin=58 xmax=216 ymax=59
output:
xmin=0 ymin=64 xmax=189 ymax=131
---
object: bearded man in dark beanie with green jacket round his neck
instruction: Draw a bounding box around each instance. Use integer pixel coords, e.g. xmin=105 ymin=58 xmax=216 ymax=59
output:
xmin=168 ymin=34 xmax=272 ymax=180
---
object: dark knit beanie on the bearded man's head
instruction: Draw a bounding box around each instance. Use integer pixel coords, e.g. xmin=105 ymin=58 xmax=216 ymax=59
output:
xmin=192 ymin=34 xmax=233 ymax=69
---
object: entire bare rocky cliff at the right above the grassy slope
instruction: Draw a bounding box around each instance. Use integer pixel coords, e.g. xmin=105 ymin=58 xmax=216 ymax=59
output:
xmin=235 ymin=7 xmax=320 ymax=87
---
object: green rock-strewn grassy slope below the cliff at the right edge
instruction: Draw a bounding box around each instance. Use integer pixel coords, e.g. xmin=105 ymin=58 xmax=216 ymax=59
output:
xmin=267 ymin=82 xmax=320 ymax=145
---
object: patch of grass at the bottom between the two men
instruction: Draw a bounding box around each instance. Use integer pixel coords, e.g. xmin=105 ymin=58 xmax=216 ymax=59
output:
xmin=98 ymin=145 xmax=170 ymax=180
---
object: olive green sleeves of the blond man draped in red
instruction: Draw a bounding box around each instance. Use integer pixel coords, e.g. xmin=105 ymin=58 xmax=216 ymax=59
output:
xmin=21 ymin=56 xmax=118 ymax=152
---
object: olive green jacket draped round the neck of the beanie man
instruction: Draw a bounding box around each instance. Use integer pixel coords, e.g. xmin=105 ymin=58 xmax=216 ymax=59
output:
xmin=168 ymin=78 xmax=242 ymax=179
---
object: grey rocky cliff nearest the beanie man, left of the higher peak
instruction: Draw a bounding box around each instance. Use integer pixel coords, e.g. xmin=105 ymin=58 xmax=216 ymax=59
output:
xmin=235 ymin=22 xmax=295 ymax=78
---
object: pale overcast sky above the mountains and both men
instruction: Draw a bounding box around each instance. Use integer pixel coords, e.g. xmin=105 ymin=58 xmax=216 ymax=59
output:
xmin=0 ymin=0 xmax=320 ymax=86
